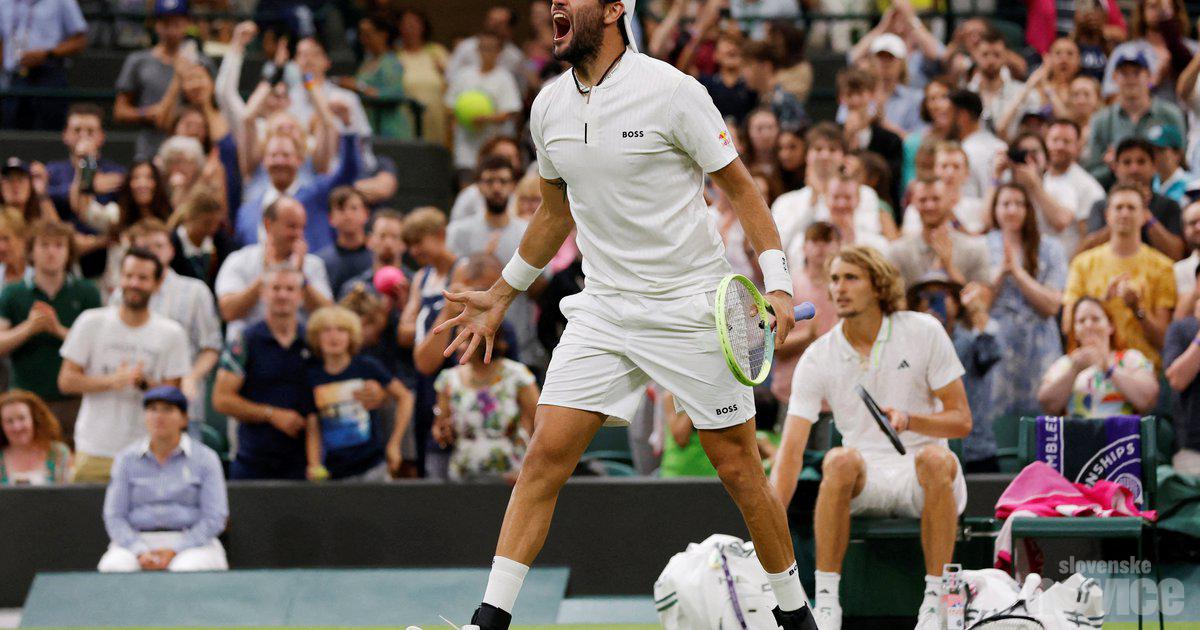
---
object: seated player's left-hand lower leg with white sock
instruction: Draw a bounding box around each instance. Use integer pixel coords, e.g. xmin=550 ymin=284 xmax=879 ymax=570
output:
xmin=814 ymin=446 xmax=866 ymax=630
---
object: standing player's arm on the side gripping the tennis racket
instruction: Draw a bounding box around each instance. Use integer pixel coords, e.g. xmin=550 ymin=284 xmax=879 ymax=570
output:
xmin=709 ymin=157 xmax=796 ymax=350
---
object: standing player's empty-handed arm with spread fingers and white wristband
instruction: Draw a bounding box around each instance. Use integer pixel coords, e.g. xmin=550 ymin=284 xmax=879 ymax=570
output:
xmin=433 ymin=179 xmax=576 ymax=364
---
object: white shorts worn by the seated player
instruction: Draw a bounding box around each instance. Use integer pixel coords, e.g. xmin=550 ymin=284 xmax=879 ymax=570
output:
xmin=850 ymin=451 xmax=967 ymax=518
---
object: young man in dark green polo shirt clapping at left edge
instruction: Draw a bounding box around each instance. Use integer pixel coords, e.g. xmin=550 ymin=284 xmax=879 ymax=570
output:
xmin=0 ymin=220 xmax=101 ymax=443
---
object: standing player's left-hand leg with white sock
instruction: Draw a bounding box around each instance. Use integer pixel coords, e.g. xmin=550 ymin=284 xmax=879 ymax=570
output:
xmin=470 ymin=404 xmax=605 ymax=630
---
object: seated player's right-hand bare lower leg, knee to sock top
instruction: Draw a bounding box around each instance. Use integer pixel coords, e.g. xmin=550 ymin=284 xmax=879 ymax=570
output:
xmin=917 ymin=445 xmax=959 ymax=575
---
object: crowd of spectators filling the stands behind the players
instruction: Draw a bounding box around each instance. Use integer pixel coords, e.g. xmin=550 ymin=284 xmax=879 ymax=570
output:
xmin=0 ymin=0 xmax=1200 ymax=516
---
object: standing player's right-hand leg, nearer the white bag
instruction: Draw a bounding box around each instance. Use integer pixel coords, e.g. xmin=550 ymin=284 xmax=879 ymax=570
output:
xmin=698 ymin=419 xmax=817 ymax=630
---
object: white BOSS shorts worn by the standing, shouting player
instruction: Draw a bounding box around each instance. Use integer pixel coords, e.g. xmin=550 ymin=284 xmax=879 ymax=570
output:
xmin=538 ymin=292 xmax=755 ymax=428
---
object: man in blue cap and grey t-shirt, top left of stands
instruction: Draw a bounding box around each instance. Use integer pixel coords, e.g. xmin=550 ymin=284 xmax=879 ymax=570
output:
xmin=113 ymin=0 xmax=214 ymax=160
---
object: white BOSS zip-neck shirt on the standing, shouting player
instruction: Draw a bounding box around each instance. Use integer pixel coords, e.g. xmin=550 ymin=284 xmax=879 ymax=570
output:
xmin=529 ymin=50 xmax=737 ymax=298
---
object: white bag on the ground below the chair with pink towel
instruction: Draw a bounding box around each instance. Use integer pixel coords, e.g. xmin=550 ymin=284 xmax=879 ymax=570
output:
xmin=962 ymin=569 xmax=1104 ymax=630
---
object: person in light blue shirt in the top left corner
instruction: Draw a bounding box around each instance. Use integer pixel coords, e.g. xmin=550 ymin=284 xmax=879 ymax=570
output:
xmin=0 ymin=0 xmax=88 ymax=130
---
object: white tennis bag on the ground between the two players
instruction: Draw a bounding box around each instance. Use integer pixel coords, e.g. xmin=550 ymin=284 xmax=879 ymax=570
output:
xmin=654 ymin=534 xmax=779 ymax=630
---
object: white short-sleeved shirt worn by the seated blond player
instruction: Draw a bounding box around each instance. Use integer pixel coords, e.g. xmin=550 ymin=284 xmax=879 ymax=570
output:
xmin=787 ymin=311 xmax=965 ymax=455
